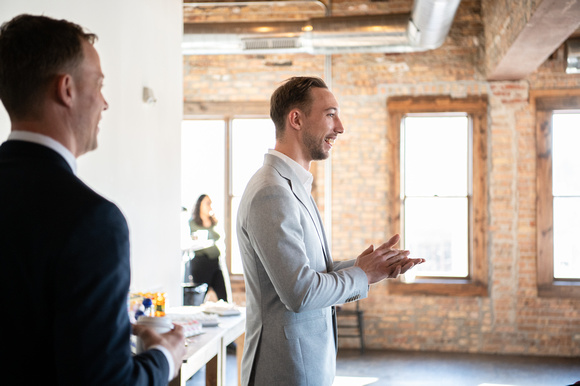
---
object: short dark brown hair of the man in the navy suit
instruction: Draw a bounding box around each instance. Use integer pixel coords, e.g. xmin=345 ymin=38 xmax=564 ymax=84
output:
xmin=0 ymin=14 xmax=97 ymax=118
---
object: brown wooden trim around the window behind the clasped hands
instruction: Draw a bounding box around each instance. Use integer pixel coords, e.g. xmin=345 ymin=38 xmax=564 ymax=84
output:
xmin=387 ymin=96 xmax=488 ymax=296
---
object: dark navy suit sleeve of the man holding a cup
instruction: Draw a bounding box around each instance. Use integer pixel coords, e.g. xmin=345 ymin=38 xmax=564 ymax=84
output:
xmin=53 ymin=201 xmax=169 ymax=385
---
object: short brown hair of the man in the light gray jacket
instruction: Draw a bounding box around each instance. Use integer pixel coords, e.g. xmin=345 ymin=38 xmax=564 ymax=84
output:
xmin=270 ymin=76 xmax=328 ymax=138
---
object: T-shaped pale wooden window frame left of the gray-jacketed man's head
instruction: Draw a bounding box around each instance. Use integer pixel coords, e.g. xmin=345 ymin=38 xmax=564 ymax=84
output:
xmin=183 ymin=101 xmax=270 ymax=281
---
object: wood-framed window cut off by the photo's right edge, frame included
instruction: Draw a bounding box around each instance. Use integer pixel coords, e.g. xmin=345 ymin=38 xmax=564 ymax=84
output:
xmin=532 ymin=90 xmax=580 ymax=297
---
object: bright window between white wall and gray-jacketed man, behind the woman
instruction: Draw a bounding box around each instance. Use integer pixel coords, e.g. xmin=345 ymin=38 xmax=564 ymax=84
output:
xmin=181 ymin=103 xmax=275 ymax=275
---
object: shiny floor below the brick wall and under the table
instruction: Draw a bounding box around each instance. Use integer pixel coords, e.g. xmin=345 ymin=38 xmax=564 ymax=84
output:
xmin=187 ymin=349 xmax=580 ymax=386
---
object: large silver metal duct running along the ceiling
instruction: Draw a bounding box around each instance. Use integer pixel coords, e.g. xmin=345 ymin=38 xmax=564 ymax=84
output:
xmin=182 ymin=0 xmax=461 ymax=55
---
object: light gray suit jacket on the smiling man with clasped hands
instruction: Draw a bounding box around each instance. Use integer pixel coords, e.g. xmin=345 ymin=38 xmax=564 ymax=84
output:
xmin=237 ymin=154 xmax=368 ymax=386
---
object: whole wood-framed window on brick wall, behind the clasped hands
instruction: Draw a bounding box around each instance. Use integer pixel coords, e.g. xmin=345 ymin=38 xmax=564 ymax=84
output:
xmin=387 ymin=97 xmax=487 ymax=296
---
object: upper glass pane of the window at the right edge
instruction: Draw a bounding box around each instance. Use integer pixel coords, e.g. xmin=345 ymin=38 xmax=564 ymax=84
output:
xmin=552 ymin=113 xmax=580 ymax=196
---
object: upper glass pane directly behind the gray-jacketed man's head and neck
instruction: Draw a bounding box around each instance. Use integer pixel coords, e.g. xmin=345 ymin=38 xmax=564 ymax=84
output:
xmin=232 ymin=119 xmax=276 ymax=196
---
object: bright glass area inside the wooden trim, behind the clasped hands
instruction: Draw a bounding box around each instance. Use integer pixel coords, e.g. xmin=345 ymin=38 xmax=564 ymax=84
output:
xmin=401 ymin=114 xmax=471 ymax=280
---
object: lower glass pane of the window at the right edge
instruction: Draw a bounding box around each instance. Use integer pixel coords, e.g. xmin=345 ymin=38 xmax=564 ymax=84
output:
xmin=554 ymin=197 xmax=580 ymax=279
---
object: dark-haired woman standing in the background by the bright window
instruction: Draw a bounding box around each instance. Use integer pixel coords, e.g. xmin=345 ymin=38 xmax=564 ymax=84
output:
xmin=189 ymin=194 xmax=228 ymax=302
